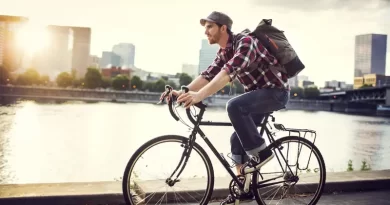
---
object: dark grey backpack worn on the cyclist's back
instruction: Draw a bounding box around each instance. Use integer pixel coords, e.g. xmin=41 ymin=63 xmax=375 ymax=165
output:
xmin=250 ymin=19 xmax=305 ymax=78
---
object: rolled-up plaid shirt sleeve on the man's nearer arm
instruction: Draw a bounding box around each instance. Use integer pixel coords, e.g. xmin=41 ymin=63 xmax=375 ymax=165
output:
xmin=222 ymin=36 xmax=256 ymax=81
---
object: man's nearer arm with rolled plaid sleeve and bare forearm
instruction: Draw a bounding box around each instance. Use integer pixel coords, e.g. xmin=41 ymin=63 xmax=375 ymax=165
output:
xmin=199 ymin=37 xmax=256 ymax=99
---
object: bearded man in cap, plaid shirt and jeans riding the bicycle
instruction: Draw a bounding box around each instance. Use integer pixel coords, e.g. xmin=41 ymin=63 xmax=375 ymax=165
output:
xmin=161 ymin=11 xmax=289 ymax=204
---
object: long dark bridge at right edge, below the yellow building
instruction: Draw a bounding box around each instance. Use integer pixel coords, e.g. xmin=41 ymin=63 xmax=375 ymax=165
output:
xmin=320 ymin=86 xmax=390 ymax=106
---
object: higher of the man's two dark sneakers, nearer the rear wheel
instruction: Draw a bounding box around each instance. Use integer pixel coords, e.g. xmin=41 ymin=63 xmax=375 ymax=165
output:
xmin=241 ymin=148 xmax=275 ymax=175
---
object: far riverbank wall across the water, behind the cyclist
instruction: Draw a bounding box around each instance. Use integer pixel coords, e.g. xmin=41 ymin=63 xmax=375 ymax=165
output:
xmin=0 ymin=83 xmax=390 ymax=116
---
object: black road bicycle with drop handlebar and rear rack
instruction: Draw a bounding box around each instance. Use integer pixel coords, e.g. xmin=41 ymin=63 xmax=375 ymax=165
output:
xmin=122 ymin=85 xmax=326 ymax=205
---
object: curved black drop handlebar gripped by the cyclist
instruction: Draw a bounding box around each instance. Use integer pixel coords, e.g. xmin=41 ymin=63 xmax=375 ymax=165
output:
xmin=158 ymin=85 xmax=207 ymax=124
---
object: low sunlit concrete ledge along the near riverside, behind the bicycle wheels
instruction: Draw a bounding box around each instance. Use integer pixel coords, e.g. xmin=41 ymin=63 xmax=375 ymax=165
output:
xmin=0 ymin=170 xmax=390 ymax=205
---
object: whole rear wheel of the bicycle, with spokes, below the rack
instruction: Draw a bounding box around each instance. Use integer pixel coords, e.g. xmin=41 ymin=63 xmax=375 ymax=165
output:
xmin=252 ymin=136 xmax=326 ymax=205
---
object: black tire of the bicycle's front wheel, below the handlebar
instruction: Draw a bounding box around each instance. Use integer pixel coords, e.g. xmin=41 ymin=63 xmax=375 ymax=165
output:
xmin=122 ymin=135 xmax=214 ymax=205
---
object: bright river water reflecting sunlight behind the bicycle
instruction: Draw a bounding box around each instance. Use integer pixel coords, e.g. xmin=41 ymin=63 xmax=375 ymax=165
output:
xmin=0 ymin=101 xmax=390 ymax=184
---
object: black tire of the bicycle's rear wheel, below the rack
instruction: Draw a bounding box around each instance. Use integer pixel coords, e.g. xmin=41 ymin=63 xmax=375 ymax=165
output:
xmin=252 ymin=136 xmax=326 ymax=205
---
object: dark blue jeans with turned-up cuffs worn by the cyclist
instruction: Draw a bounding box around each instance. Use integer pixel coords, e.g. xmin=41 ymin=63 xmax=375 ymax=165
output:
xmin=226 ymin=88 xmax=290 ymax=164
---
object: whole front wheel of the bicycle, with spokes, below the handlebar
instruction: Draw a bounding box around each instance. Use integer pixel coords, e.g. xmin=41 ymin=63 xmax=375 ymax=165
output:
xmin=122 ymin=135 xmax=214 ymax=205
